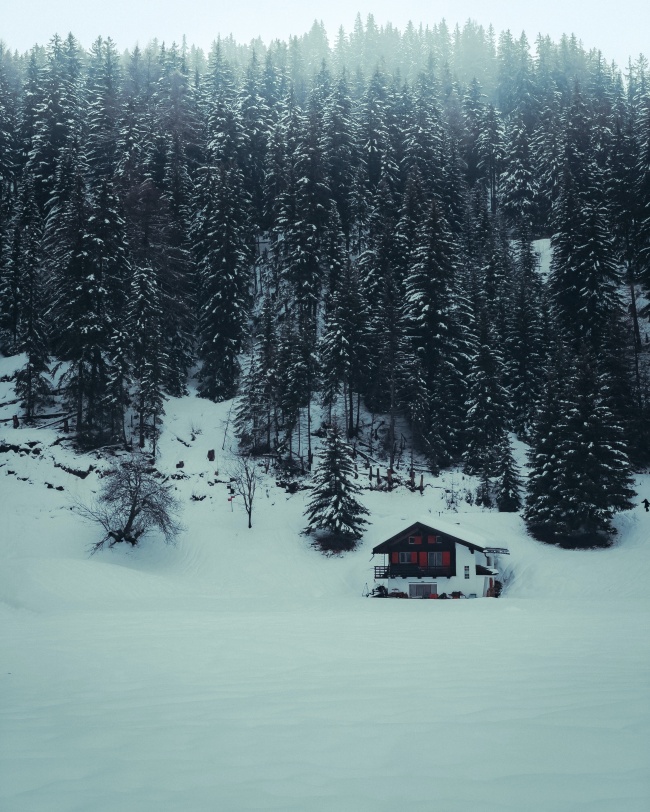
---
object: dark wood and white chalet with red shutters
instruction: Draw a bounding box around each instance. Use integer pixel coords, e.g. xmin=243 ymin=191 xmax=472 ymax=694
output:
xmin=372 ymin=522 xmax=509 ymax=598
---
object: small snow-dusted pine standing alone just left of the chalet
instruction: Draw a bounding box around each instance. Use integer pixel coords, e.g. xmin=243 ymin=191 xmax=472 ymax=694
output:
xmin=305 ymin=425 xmax=369 ymax=551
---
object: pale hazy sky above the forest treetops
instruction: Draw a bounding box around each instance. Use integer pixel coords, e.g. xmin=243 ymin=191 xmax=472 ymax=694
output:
xmin=0 ymin=0 xmax=650 ymax=67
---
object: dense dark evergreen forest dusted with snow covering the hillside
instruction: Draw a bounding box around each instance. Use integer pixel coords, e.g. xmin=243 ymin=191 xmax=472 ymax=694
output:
xmin=0 ymin=17 xmax=650 ymax=536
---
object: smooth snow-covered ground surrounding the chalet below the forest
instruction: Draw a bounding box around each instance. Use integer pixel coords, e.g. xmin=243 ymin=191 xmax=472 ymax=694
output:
xmin=0 ymin=369 xmax=650 ymax=812
